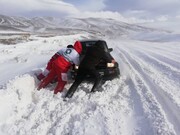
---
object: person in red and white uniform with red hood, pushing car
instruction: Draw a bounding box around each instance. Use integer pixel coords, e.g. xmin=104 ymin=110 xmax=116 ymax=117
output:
xmin=37 ymin=41 xmax=82 ymax=94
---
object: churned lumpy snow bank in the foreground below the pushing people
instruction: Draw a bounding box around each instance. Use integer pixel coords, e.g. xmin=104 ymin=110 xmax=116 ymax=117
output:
xmin=0 ymin=74 xmax=134 ymax=135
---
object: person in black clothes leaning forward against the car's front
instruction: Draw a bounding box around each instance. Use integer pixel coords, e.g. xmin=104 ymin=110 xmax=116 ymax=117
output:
xmin=65 ymin=40 xmax=114 ymax=98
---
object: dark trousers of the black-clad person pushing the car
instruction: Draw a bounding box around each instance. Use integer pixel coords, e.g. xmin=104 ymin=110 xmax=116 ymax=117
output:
xmin=65 ymin=68 xmax=102 ymax=98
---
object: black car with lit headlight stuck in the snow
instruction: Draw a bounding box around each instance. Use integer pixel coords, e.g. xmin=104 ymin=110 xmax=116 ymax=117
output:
xmin=71 ymin=40 xmax=120 ymax=80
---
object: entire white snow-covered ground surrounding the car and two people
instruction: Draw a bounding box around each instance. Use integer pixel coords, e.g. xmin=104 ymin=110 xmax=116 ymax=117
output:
xmin=0 ymin=17 xmax=180 ymax=135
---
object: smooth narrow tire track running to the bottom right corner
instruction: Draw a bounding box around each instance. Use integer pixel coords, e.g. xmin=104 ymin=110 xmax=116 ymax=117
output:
xmin=119 ymin=49 xmax=180 ymax=134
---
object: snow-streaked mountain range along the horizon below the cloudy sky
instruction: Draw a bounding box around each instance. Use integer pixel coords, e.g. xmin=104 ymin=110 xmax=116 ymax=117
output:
xmin=0 ymin=15 xmax=159 ymax=37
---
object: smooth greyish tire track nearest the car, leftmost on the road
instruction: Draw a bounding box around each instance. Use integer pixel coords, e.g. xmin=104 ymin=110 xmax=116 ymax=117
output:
xmin=115 ymin=47 xmax=153 ymax=135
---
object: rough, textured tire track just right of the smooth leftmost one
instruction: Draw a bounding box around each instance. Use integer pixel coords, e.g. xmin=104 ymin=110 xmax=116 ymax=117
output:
xmin=120 ymin=52 xmax=173 ymax=134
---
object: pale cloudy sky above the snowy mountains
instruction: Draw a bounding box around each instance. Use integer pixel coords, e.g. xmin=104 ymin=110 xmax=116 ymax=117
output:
xmin=0 ymin=0 xmax=180 ymax=19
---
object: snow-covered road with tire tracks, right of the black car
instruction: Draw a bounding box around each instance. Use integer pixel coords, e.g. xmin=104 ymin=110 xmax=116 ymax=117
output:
xmin=111 ymin=41 xmax=180 ymax=134
